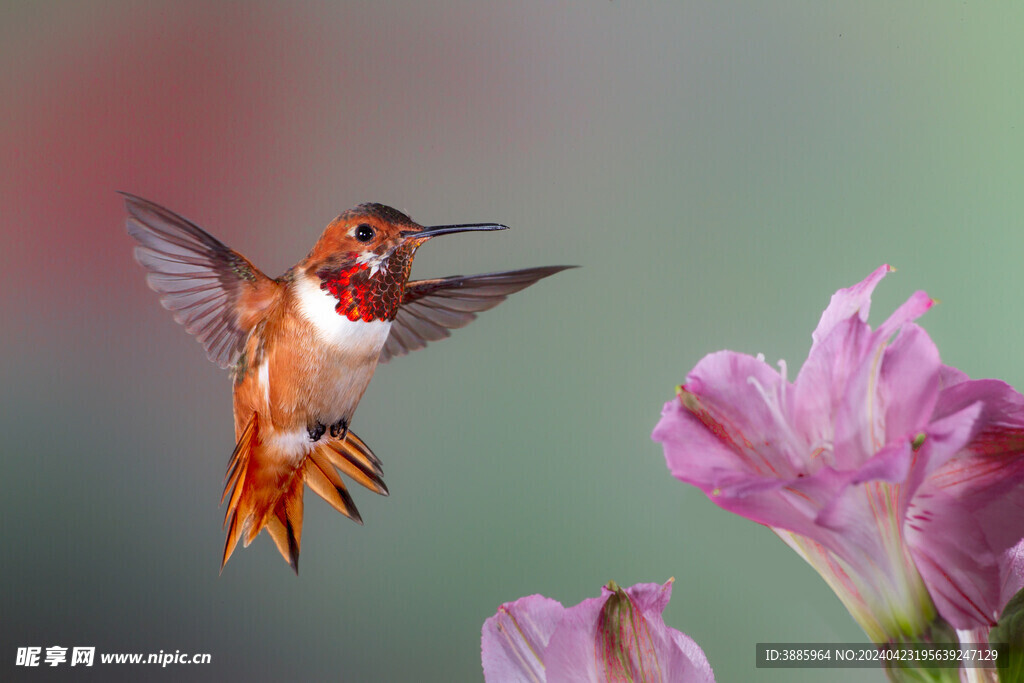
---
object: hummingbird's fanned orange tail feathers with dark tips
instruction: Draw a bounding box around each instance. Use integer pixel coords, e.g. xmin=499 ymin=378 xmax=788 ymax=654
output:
xmin=220 ymin=413 xmax=388 ymax=573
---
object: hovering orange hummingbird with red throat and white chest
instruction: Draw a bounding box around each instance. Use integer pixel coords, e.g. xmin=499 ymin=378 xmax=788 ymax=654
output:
xmin=121 ymin=193 xmax=571 ymax=573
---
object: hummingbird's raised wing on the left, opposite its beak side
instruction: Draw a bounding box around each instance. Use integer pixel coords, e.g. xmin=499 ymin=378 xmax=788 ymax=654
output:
xmin=121 ymin=193 xmax=280 ymax=368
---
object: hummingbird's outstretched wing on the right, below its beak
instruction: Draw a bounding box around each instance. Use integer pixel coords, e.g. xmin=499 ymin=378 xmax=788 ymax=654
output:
xmin=380 ymin=265 xmax=575 ymax=362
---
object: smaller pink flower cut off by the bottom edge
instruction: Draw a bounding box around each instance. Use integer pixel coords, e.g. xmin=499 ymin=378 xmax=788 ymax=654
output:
xmin=481 ymin=580 xmax=715 ymax=683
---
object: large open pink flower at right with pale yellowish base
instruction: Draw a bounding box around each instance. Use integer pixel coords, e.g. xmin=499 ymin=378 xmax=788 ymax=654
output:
xmin=653 ymin=266 xmax=1024 ymax=643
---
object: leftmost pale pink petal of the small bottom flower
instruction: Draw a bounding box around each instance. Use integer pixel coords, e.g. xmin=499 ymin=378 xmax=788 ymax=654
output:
xmin=480 ymin=595 xmax=565 ymax=683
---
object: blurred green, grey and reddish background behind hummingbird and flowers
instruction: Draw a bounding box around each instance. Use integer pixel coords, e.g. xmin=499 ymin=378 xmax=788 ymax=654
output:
xmin=0 ymin=0 xmax=1024 ymax=682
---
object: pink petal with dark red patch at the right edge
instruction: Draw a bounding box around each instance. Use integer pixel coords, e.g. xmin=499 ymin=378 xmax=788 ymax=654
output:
xmin=907 ymin=380 xmax=1024 ymax=629
